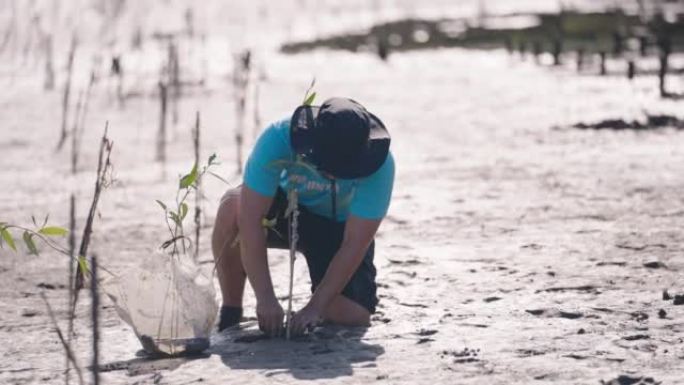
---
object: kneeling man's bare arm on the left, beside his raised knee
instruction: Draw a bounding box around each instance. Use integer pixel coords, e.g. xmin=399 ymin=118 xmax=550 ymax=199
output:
xmin=238 ymin=185 xmax=284 ymax=335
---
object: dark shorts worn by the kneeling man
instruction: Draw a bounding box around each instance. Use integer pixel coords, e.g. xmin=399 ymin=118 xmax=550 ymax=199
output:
xmin=267 ymin=189 xmax=378 ymax=314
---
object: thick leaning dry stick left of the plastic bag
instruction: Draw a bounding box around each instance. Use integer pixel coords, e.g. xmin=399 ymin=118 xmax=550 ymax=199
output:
xmin=72 ymin=122 xmax=114 ymax=292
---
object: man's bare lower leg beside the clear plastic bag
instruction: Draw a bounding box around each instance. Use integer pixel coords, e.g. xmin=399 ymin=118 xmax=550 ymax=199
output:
xmin=211 ymin=187 xmax=247 ymax=331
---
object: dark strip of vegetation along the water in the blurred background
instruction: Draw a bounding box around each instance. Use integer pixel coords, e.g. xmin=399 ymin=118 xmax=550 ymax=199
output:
xmin=281 ymin=9 xmax=684 ymax=98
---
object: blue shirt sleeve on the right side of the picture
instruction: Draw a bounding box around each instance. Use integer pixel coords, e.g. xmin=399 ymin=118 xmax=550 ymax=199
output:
xmin=349 ymin=153 xmax=394 ymax=220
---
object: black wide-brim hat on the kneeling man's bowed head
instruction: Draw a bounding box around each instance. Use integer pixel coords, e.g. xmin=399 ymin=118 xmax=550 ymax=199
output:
xmin=290 ymin=98 xmax=390 ymax=179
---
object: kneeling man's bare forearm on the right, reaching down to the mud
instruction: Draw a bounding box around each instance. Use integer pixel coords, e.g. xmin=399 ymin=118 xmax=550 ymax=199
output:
xmin=292 ymin=215 xmax=381 ymax=334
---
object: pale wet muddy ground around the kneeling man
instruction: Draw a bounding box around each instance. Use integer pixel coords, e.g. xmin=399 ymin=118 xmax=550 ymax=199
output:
xmin=0 ymin=40 xmax=684 ymax=384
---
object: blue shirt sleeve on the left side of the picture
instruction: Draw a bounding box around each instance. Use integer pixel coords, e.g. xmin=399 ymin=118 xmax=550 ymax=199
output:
xmin=244 ymin=120 xmax=291 ymax=197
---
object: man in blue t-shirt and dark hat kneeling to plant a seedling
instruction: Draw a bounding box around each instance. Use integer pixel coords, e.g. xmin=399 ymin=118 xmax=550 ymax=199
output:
xmin=212 ymin=98 xmax=394 ymax=336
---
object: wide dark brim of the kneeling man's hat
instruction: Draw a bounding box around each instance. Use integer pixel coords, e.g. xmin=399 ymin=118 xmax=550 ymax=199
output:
xmin=290 ymin=106 xmax=391 ymax=179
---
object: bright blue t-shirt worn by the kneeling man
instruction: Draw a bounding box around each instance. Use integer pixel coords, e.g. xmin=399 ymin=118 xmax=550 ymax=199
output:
xmin=244 ymin=119 xmax=394 ymax=222
